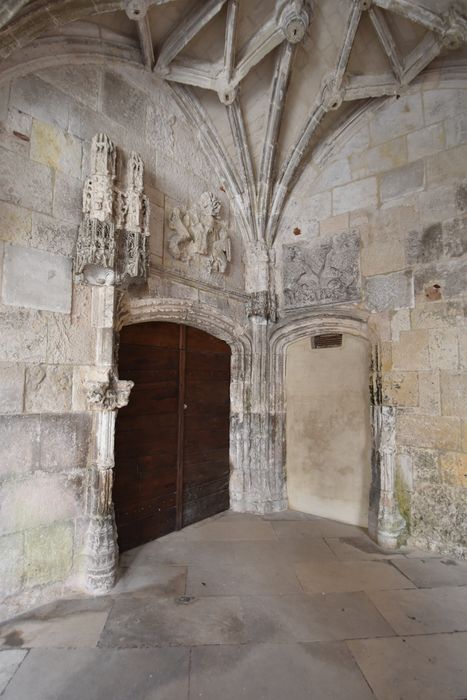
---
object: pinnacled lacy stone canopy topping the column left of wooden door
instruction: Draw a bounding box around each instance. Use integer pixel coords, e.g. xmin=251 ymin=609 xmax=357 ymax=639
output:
xmin=74 ymin=134 xmax=149 ymax=284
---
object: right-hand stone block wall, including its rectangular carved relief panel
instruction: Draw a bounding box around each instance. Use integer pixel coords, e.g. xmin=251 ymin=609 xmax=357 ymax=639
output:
xmin=277 ymin=74 xmax=467 ymax=556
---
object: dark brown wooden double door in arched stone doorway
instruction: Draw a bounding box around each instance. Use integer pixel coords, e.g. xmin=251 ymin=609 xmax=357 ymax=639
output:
xmin=114 ymin=323 xmax=230 ymax=551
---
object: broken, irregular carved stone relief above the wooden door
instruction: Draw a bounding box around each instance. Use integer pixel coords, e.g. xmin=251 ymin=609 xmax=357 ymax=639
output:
xmin=169 ymin=192 xmax=232 ymax=274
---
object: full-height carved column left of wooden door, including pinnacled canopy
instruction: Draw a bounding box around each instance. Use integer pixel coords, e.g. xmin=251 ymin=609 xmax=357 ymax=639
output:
xmin=74 ymin=134 xmax=149 ymax=593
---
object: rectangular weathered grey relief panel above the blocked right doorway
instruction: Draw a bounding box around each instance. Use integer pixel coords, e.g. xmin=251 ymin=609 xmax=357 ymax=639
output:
xmin=283 ymin=233 xmax=361 ymax=308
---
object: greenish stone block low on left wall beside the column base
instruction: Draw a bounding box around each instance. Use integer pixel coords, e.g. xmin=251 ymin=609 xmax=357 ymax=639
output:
xmin=24 ymin=523 xmax=73 ymax=586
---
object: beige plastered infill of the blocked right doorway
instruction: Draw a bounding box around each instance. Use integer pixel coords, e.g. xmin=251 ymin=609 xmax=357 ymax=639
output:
xmin=286 ymin=334 xmax=371 ymax=527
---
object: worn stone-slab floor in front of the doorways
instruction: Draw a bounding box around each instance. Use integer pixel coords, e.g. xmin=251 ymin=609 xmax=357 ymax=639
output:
xmin=0 ymin=512 xmax=467 ymax=700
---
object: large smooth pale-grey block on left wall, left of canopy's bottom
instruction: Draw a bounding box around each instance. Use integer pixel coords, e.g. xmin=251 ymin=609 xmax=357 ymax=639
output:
xmin=3 ymin=245 xmax=72 ymax=313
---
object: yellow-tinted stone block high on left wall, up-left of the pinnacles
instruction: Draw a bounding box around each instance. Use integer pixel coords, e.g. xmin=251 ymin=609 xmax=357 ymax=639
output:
xmin=30 ymin=119 xmax=81 ymax=177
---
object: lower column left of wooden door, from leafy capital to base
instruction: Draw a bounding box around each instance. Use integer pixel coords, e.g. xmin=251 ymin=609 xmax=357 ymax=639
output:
xmin=86 ymin=370 xmax=133 ymax=593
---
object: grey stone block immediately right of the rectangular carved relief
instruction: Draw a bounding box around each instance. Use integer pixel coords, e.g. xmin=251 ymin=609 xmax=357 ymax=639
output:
xmin=366 ymin=270 xmax=414 ymax=311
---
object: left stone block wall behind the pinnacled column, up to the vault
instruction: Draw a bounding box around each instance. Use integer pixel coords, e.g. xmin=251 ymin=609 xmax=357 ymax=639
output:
xmin=0 ymin=66 xmax=244 ymax=603
